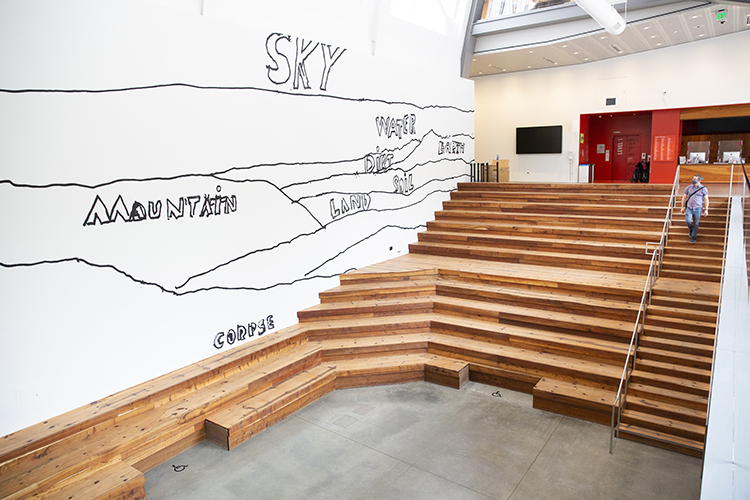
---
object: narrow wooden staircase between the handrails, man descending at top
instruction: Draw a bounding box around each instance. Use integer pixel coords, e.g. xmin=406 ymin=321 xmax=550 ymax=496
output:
xmin=620 ymin=199 xmax=728 ymax=457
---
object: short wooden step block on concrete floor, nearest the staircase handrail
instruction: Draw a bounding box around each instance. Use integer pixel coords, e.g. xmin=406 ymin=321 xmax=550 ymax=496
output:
xmin=533 ymin=378 xmax=617 ymax=425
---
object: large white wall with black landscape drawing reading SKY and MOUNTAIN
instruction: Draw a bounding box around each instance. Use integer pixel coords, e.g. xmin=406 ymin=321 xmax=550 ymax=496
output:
xmin=0 ymin=0 xmax=474 ymax=435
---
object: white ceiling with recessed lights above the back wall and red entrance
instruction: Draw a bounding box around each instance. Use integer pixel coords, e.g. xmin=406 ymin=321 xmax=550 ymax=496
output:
xmin=470 ymin=2 xmax=750 ymax=77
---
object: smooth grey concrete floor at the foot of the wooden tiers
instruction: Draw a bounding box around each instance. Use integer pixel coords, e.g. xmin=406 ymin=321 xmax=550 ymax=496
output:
xmin=146 ymin=382 xmax=701 ymax=500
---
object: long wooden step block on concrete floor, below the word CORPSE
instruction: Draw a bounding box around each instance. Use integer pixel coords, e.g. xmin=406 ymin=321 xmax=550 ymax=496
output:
xmin=206 ymin=365 xmax=336 ymax=450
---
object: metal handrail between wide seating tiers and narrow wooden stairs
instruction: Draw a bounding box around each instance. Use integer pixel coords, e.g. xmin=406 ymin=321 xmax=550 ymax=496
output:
xmin=609 ymin=165 xmax=680 ymax=453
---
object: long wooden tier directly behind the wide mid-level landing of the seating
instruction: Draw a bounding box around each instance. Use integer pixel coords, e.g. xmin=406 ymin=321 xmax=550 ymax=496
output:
xmin=409 ymin=242 xmax=649 ymax=274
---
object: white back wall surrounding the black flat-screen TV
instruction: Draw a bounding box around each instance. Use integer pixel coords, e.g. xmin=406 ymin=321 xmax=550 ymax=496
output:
xmin=474 ymin=31 xmax=750 ymax=182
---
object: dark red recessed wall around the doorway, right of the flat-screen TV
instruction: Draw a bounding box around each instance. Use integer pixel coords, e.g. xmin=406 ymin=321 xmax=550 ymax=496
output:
xmin=581 ymin=111 xmax=652 ymax=182
